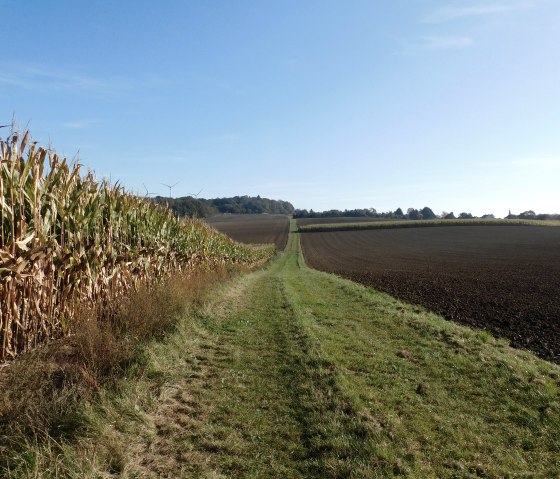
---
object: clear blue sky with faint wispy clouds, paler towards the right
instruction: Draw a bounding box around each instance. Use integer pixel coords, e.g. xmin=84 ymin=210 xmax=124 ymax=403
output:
xmin=0 ymin=0 xmax=560 ymax=217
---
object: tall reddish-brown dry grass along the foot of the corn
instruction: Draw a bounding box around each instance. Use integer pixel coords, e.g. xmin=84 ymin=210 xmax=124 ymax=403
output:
xmin=0 ymin=268 xmax=235 ymax=475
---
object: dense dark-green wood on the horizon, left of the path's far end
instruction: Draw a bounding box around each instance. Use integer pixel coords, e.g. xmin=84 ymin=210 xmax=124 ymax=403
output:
xmin=154 ymin=196 xmax=294 ymax=218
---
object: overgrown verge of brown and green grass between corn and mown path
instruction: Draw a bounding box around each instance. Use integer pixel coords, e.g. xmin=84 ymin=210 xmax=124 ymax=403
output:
xmin=0 ymin=269 xmax=238 ymax=477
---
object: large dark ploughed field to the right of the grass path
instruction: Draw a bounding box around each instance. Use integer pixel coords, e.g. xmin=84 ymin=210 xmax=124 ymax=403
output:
xmin=301 ymin=226 xmax=560 ymax=362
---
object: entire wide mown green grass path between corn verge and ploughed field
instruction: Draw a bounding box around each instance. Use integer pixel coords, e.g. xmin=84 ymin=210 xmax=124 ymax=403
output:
xmin=123 ymin=234 xmax=560 ymax=478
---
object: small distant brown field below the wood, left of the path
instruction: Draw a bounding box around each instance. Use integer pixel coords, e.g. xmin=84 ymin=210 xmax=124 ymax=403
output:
xmin=204 ymin=215 xmax=290 ymax=250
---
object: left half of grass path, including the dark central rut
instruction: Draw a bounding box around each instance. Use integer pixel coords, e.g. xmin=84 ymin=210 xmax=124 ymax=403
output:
xmin=127 ymin=234 xmax=378 ymax=478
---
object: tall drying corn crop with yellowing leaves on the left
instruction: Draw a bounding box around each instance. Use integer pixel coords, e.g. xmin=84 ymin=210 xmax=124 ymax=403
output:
xmin=0 ymin=132 xmax=273 ymax=360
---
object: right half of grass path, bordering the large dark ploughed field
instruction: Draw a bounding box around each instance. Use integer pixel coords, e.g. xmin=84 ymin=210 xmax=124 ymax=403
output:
xmin=291 ymin=232 xmax=560 ymax=478
